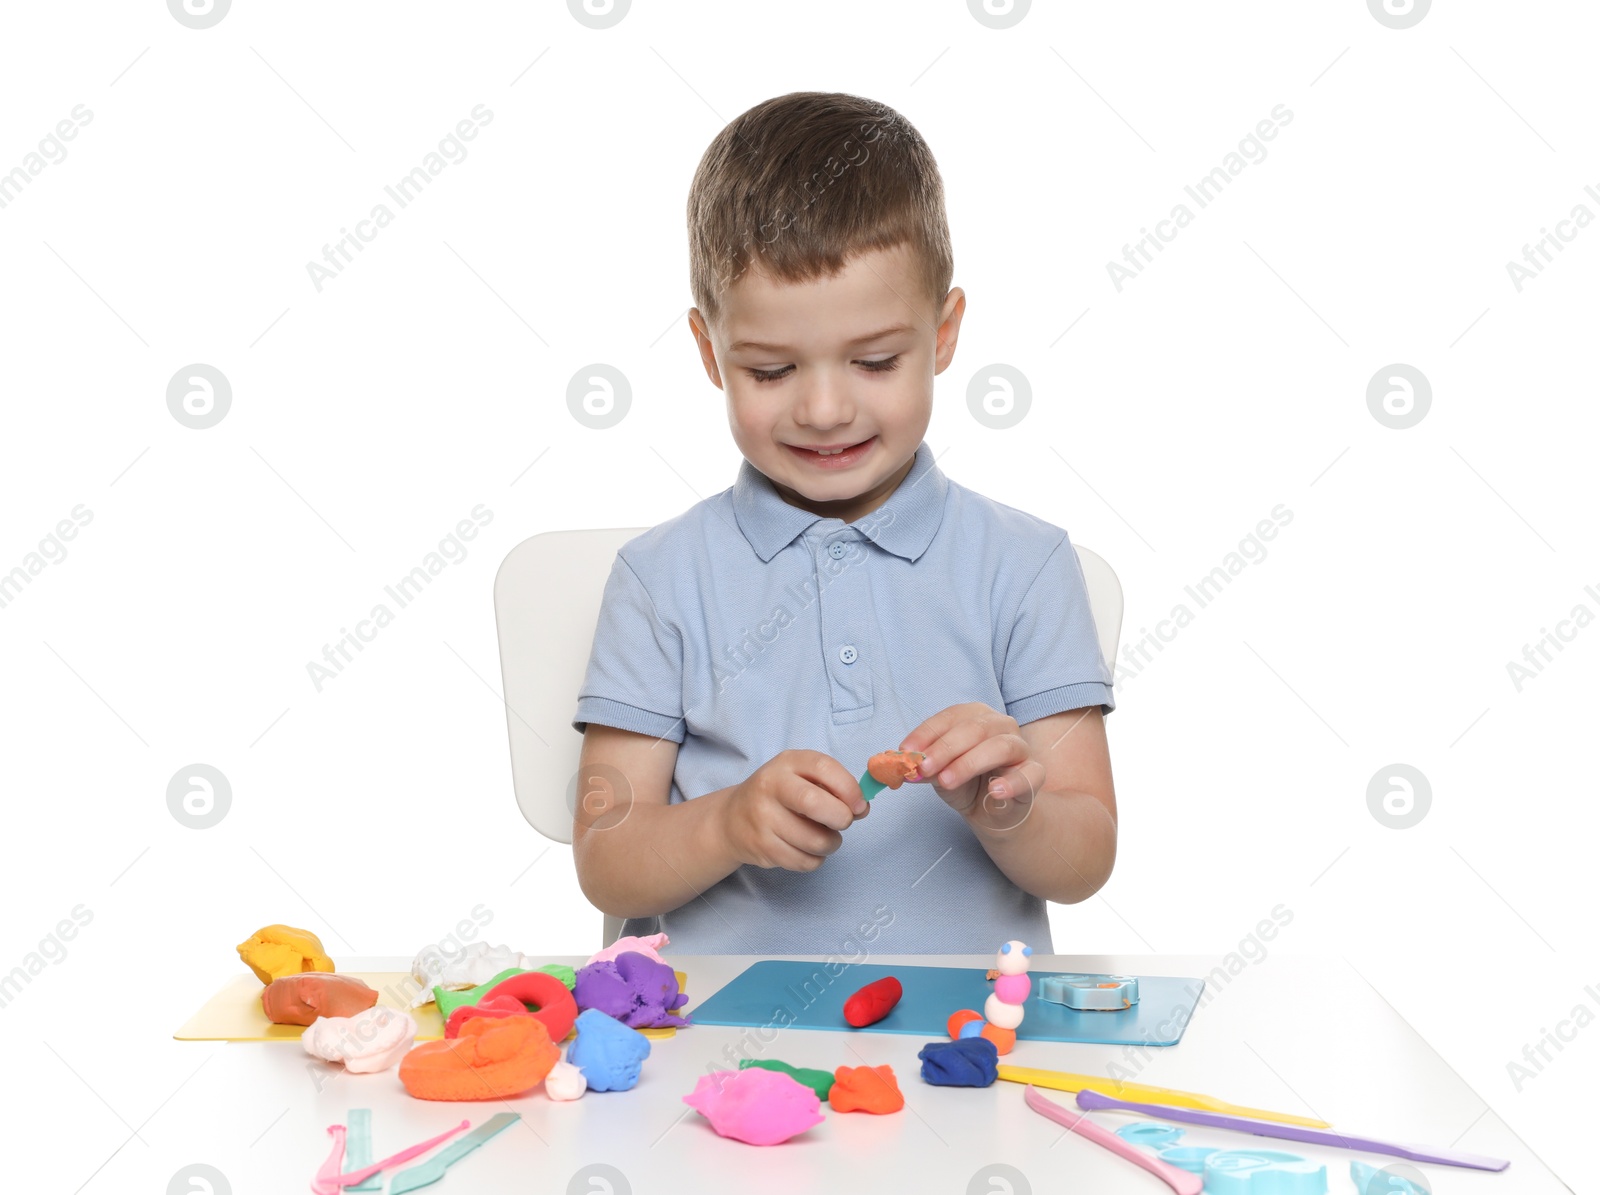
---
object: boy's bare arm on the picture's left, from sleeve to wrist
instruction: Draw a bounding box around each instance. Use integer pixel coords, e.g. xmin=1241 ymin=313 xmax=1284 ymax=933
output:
xmin=573 ymin=721 xmax=739 ymax=917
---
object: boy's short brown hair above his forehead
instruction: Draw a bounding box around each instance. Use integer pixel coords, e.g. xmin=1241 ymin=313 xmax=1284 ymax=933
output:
xmin=688 ymin=91 xmax=955 ymax=329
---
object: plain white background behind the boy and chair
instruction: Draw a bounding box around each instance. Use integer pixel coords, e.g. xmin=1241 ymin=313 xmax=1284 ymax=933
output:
xmin=0 ymin=0 xmax=1600 ymax=1192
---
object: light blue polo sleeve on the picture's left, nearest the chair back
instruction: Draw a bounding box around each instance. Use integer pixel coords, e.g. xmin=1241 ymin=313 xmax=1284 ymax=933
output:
xmin=573 ymin=554 xmax=686 ymax=742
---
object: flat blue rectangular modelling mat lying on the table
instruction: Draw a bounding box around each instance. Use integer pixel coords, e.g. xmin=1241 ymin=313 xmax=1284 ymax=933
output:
xmin=686 ymin=958 xmax=1205 ymax=1046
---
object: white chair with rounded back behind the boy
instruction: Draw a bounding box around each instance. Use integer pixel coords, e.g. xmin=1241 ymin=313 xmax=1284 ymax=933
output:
xmin=494 ymin=526 xmax=1122 ymax=945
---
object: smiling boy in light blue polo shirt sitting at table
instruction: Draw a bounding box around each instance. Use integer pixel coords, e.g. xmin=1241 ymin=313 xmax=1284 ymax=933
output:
xmin=573 ymin=93 xmax=1117 ymax=957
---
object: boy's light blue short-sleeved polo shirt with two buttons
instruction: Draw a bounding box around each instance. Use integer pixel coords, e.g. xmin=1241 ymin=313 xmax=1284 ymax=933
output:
xmin=573 ymin=442 xmax=1115 ymax=958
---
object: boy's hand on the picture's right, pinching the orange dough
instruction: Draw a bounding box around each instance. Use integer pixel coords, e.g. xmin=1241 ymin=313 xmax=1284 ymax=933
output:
xmin=899 ymin=701 xmax=1045 ymax=829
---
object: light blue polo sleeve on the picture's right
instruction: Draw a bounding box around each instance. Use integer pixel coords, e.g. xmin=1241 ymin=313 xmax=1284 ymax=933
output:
xmin=1000 ymin=536 xmax=1117 ymax=725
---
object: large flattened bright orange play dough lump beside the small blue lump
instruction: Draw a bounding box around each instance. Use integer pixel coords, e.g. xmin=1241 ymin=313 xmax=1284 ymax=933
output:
xmin=400 ymin=1016 xmax=562 ymax=1099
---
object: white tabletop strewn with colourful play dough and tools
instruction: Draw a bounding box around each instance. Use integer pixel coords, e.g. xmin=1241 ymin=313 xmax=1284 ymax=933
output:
xmin=159 ymin=955 xmax=1566 ymax=1195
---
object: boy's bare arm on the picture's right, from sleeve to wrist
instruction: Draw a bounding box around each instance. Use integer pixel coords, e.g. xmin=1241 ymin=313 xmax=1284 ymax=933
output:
xmin=965 ymin=705 xmax=1117 ymax=904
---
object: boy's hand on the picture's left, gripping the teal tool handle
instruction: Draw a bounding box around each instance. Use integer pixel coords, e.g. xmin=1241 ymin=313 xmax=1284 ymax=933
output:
xmin=723 ymin=750 xmax=872 ymax=872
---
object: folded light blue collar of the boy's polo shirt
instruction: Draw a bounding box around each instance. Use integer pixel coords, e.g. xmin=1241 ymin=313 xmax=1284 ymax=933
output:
xmin=733 ymin=440 xmax=950 ymax=563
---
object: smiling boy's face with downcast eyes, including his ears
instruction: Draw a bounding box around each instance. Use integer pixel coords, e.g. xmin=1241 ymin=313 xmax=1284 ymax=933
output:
xmin=690 ymin=246 xmax=966 ymax=523
